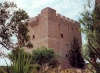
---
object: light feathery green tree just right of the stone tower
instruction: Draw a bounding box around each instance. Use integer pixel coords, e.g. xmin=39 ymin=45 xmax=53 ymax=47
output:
xmin=79 ymin=0 xmax=94 ymax=43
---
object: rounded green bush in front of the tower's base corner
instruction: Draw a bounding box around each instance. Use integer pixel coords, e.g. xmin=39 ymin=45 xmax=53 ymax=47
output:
xmin=32 ymin=47 xmax=59 ymax=67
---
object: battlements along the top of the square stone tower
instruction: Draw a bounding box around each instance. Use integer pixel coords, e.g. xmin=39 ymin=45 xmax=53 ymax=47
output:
xmin=29 ymin=7 xmax=79 ymax=24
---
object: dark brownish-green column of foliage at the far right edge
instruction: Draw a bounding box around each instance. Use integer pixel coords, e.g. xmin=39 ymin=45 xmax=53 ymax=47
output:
xmin=93 ymin=6 xmax=100 ymax=48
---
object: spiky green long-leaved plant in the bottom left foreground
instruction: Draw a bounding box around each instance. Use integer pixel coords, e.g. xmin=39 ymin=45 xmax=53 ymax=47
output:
xmin=0 ymin=47 xmax=38 ymax=73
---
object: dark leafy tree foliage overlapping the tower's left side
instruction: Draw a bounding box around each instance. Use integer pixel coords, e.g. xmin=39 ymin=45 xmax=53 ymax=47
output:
xmin=11 ymin=9 xmax=32 ymax=48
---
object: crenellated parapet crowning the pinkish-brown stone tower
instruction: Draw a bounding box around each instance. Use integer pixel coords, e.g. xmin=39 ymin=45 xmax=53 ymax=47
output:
xmin=29 ymin=7 xmax=80 ymax=25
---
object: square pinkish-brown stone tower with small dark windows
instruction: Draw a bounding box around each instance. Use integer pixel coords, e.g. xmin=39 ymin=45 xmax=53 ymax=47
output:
xmin=26 ymin=7 xmax=82 ymax=69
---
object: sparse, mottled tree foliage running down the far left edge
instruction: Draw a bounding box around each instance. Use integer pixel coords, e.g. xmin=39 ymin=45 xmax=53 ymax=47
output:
xmin=0 ymin=2 xmax=16 ymax=49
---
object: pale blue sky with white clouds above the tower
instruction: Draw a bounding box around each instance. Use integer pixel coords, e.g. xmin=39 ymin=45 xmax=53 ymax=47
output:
xmin=0 ymin=0 xmax=93 ymax=65
